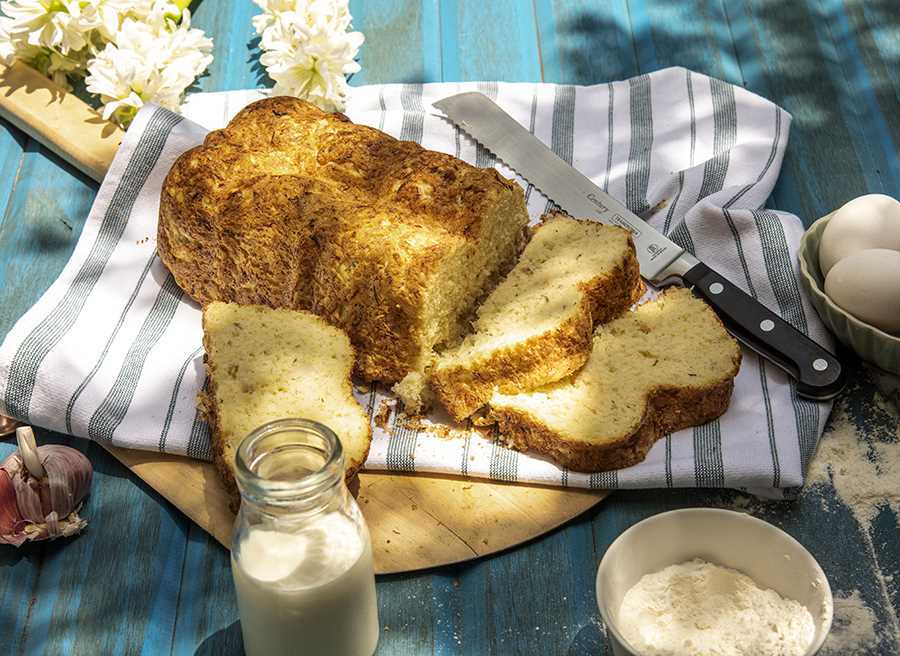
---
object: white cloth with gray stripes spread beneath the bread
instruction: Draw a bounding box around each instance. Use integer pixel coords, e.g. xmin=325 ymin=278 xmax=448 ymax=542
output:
xmin=0 ymin=68 xmax=829 ymax=494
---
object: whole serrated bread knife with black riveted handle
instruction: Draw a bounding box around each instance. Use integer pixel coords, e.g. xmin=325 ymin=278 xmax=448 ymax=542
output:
xmin=433 ymin=92 xmax=844 ymax=400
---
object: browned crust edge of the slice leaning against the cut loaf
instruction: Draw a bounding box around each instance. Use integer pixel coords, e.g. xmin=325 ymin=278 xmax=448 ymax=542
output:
xmin=431 ymin=226 xmax=644 ymax=421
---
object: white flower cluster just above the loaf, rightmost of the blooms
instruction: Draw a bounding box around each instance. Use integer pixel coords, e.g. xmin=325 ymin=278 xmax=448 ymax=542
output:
xmin=253 ymin=0 xmax=364 ymax=111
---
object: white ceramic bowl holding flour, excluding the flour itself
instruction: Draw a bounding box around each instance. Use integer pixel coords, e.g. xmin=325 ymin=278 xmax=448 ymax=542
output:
xmin=597 ymin=508 xmax=833 ymax=656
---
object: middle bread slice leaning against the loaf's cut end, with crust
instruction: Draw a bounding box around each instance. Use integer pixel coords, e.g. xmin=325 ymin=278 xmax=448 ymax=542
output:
xmin=431 ymin=213 xmax=643 ymax=421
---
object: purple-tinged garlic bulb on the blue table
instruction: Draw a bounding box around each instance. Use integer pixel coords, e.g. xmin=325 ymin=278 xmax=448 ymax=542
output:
xmin=0 ymin=426 xmax=93 ymax=547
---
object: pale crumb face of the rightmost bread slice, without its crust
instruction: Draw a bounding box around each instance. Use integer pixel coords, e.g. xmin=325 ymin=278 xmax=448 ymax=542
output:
xmin=491 ymin=289 xmax=740 ymax=444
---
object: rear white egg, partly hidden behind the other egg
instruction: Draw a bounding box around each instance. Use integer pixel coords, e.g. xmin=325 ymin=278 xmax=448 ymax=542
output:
xmin=819 ymin=194 xmax=900 ymax=276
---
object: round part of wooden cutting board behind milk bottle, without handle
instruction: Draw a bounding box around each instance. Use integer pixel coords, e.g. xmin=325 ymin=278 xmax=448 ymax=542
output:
xmin=105 ymin=447 xmax=608 ymax=574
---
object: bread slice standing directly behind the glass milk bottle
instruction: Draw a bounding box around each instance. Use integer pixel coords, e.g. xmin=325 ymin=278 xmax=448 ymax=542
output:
xmin=201 ymin=302 xmax=372 ymax=508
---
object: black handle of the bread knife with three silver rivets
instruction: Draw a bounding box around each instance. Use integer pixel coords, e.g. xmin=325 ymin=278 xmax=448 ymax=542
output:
xmin=682 ymin=262 xmax=844 ymax=400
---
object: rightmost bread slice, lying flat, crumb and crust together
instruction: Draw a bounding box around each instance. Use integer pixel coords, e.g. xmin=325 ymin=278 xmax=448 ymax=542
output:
xmin=489 ymin=289 xmax=741 ymax=472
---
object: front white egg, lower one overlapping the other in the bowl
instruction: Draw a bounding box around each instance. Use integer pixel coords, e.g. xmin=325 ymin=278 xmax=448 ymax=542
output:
xmin=825 ymin=248 xmax=900 ymax=333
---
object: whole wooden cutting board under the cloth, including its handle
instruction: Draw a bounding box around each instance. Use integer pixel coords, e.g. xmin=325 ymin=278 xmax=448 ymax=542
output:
xmin=0 ymin=63 xmax=608 ymax=574
